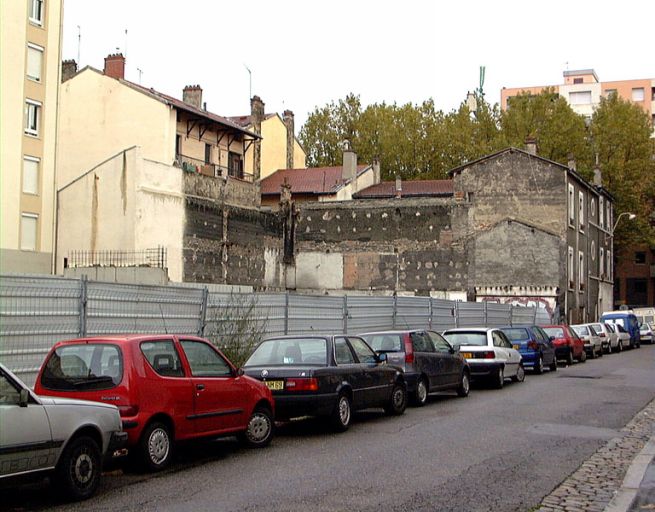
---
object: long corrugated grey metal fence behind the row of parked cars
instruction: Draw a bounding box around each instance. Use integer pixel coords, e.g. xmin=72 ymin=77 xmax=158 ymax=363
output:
xmin=0 ymin=275 xmax=550 ymax=384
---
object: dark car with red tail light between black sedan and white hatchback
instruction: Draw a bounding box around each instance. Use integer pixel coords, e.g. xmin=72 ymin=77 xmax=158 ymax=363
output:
xmin=359 ymin=329 xmax=471 ymax=406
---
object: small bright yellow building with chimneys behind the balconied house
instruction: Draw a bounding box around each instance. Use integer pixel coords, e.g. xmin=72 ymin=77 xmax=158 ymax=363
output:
xmin=229 ymin=96 xmax=306 ymax=180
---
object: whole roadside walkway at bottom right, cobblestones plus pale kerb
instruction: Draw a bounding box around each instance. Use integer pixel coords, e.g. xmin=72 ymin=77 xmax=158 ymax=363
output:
xmin=538 ymin=400 xmax=655 ymax=512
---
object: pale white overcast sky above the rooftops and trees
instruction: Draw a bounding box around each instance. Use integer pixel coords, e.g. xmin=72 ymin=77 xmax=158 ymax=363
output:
xmin=63 ymin=0 xmax=655 ymax=131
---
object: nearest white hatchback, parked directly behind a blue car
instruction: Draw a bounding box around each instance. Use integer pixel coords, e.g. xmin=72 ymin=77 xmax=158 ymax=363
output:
xmin=443 ymin=327 xmax=525 ymax=388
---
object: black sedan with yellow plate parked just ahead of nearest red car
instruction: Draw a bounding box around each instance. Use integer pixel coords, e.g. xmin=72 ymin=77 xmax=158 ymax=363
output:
xmin=243 ymin=335 xmax=407 ymax=432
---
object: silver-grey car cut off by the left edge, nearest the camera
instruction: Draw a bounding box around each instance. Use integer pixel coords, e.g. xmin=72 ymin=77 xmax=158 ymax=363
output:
xmin=0 ymin=364 xmax=127 ymax=500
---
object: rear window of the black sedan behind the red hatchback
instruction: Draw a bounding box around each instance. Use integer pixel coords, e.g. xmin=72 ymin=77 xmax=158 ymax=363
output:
xmin=244 ymin=338 xmax=327 ymax=366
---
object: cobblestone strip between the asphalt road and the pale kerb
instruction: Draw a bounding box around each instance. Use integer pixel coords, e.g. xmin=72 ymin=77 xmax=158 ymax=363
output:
xmin=537 ymin=400 xmax=655 ymax=512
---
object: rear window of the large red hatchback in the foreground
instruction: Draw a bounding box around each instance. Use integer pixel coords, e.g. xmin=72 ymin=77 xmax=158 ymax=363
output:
xmin=41 ymin=343 xmax=123 ymax=391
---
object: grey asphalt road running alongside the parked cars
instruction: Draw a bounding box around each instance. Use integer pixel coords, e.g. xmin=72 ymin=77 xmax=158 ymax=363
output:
xmin=5 ymin=346 xmax=655 ymax=512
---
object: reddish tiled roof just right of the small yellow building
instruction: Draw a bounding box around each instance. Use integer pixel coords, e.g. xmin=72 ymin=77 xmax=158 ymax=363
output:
xmin=261 ymin=165 xmax=370 ymax=195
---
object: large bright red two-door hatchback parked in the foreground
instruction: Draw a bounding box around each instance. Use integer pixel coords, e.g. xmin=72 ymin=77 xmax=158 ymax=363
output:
xmin=34 ymin=335 xmax=274 ymax=471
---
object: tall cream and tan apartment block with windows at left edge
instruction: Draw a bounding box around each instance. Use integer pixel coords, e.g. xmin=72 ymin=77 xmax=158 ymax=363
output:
xmin=0 ymin=0 xmax=62 ymax=273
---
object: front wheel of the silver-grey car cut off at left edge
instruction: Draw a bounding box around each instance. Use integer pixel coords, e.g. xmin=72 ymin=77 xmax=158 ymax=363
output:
xmin=54 ymin=436 xmax=102 ymax=500
